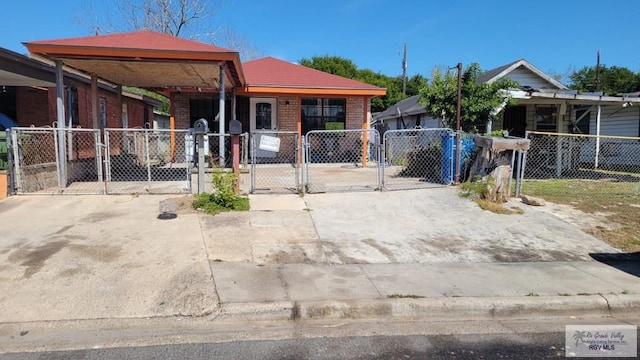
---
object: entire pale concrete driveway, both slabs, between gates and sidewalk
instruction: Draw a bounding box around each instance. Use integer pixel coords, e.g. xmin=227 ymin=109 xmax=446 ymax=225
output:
xmin=0 ymin=188 xmax=617 ymax=322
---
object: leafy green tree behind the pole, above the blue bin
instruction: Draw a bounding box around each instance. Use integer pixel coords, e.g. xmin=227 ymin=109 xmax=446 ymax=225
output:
xmin=420 ymin=63 xmax=518 ymax=132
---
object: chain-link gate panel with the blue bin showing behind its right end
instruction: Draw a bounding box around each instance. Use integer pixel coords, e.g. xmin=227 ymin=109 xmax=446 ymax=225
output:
xmin=381 ymin=128 xmax=455 ymax=190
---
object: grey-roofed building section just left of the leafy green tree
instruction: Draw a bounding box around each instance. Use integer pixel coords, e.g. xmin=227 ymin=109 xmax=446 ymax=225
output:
xmin=372 ymin=95 xmax=444 ymax=133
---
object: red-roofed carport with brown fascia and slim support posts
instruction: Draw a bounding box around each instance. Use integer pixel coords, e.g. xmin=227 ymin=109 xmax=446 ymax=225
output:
xmin=24 ymin=31 xmax=245 ymax=186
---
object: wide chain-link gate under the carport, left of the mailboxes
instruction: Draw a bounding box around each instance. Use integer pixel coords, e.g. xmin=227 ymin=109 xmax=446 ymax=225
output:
xmin=104 ymin=129 xmax=194 ymax=194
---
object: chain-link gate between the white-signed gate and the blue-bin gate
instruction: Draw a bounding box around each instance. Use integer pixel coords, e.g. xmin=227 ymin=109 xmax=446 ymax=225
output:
xmin=304 ymin=129 xmax=381 ymax=193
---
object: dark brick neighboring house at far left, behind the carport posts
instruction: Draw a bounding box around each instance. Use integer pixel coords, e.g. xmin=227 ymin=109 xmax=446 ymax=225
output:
xmin=0 ymin=48 xmax=160 ymax=128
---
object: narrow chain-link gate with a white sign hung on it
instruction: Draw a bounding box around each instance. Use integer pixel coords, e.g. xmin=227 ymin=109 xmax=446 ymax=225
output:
xmin=250 ymin=130 xmax=302 ymax=193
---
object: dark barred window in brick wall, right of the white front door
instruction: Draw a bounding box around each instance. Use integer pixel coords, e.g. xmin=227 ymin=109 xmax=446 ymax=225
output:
xmin=301 ymin=98 xmax=347 ymax=134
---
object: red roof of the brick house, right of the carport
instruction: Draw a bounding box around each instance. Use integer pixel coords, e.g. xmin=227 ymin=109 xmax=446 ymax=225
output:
xmin=242 ymin=57 xmax=385 ymax=91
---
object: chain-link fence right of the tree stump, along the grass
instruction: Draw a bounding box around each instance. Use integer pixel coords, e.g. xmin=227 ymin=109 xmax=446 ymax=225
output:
xmin=516 ymin=131 xmax=640 ymax=197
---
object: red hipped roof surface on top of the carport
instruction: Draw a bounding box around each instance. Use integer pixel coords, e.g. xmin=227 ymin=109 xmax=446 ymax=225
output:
xmin=25 ymin=31 xmax=235 ymax=53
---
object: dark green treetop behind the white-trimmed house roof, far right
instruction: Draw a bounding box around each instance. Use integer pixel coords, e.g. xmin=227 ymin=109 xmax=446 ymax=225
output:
xmin=569 ymin=65 xmax=640 ymax=95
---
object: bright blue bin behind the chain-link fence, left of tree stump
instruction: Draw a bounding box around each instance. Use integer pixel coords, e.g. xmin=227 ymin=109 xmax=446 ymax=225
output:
xmin=440 ymin=132 xmax=476 ymax=184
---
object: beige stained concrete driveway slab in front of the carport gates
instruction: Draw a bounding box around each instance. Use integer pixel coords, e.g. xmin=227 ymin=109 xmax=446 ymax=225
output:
xmin=0 ymin=196 xmax=218 ymax=322
